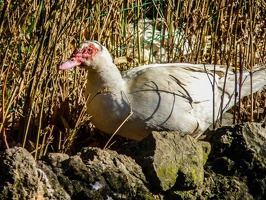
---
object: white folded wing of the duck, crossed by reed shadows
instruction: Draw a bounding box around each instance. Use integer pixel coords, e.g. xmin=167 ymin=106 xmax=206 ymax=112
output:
xmin=123 ymin=63 xmax=264 ymax=137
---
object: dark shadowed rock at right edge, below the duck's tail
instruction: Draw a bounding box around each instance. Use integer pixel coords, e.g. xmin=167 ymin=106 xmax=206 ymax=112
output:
xmin=205 ymin=123 xmax=266 ymax=199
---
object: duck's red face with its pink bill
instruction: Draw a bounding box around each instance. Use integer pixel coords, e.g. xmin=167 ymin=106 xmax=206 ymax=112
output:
xmin=59 ymin=42 xmax=99 ymax=70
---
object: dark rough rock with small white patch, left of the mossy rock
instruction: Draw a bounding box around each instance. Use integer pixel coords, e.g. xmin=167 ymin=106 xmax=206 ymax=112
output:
xmin=40 ymin=147 xmax=152 ymax=199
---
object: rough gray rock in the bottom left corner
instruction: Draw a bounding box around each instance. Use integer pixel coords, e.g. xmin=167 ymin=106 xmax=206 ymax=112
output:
xmin=0 ymin=147 xmax=70 ymax=199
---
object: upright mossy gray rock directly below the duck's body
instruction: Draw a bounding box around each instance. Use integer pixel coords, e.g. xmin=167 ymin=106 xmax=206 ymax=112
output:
xmin=121 ymin=132 xmax=210 ymax=193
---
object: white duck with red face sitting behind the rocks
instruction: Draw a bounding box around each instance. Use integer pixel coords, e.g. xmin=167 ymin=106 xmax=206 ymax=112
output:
xmin=59 ymin=41 xmax=266 ymax=140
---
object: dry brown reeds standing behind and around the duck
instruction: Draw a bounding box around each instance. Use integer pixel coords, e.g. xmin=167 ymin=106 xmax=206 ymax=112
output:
xmin=0 ymin=0 xmax=266 ymax=158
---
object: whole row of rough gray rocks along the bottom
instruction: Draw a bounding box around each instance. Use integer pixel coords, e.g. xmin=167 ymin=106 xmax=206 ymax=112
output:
xmin=0 ymin=123 xmax=266 ymax=200
